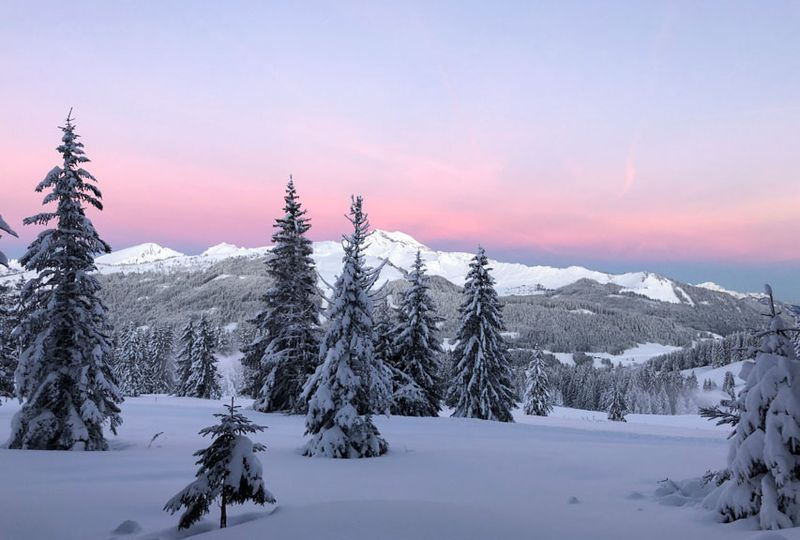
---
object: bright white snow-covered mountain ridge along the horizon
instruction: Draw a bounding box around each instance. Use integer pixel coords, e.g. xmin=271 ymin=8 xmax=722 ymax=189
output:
xmin=36 ymin=230 xmax=736 ymax=305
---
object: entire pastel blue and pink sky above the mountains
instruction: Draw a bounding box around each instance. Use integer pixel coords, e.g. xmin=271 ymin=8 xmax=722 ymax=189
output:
xmin=0 ymin=0 xmax=800 ymax=302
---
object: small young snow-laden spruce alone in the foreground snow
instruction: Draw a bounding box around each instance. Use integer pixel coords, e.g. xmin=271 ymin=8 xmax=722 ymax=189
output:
xmin=164 ymin=398 xmax=275 ymax=530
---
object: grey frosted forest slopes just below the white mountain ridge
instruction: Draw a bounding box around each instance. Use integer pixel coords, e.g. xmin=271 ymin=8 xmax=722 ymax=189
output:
xmin=90 ymin=257 xmax=760 ymax=360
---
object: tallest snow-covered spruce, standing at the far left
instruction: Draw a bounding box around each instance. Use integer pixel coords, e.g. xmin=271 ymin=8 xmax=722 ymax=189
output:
xmin=8 ymin=110 xmax=122 ymax=450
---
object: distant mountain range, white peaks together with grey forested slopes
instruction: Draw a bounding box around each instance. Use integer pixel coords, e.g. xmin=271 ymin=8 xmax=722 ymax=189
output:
xmin=0 ymin=231 xmax=776 ymax=353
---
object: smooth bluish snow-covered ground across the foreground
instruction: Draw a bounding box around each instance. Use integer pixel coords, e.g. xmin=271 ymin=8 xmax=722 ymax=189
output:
xmin=0 ymin=396 xmax=800 ymax=540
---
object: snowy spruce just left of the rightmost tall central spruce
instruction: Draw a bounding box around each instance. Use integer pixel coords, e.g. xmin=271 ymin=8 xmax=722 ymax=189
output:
xmin=392 ymin=251 xmax=442 ymax=416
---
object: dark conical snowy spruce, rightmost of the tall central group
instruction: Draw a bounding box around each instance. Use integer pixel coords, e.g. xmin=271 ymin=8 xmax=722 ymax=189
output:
xmin=449 ymin=247 xmax=515 ymax=422
